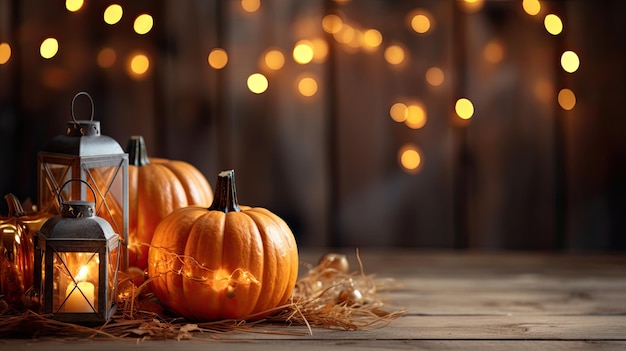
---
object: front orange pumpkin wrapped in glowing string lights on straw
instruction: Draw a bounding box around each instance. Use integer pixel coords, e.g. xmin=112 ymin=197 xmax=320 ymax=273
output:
xmin=148 ymin=170 xmax=298 ymax=321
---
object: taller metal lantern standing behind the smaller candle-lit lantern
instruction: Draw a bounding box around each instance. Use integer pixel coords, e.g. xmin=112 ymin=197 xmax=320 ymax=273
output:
xmin=37 ymin=92 xmax=129 ymax=270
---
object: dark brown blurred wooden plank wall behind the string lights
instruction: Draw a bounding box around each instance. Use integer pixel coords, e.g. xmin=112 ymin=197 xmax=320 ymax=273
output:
xmin=0 ymin=0 xmax=626 ymax=250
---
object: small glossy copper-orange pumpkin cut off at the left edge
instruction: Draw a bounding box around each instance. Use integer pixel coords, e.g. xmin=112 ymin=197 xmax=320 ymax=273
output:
xmin=0 ymin=194 xmax=52 ymax=305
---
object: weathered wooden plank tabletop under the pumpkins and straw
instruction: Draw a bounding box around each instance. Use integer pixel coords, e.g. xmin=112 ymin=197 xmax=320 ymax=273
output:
xmin=0 ymin=249 xmax=626 ymax=351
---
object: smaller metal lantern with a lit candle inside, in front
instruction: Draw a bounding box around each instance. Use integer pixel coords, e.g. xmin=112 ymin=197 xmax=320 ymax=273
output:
xmin=35 ymin=180 xmax=120 ymax=324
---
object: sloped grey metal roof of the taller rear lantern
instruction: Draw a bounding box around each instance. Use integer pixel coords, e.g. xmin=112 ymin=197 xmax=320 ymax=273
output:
xmin=43 ymin=120 xmax=124 ymax=156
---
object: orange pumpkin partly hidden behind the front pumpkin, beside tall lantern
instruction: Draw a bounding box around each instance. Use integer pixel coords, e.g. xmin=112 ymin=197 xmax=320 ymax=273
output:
xmin=127 ymin=136 xmax=213 ymax=269
